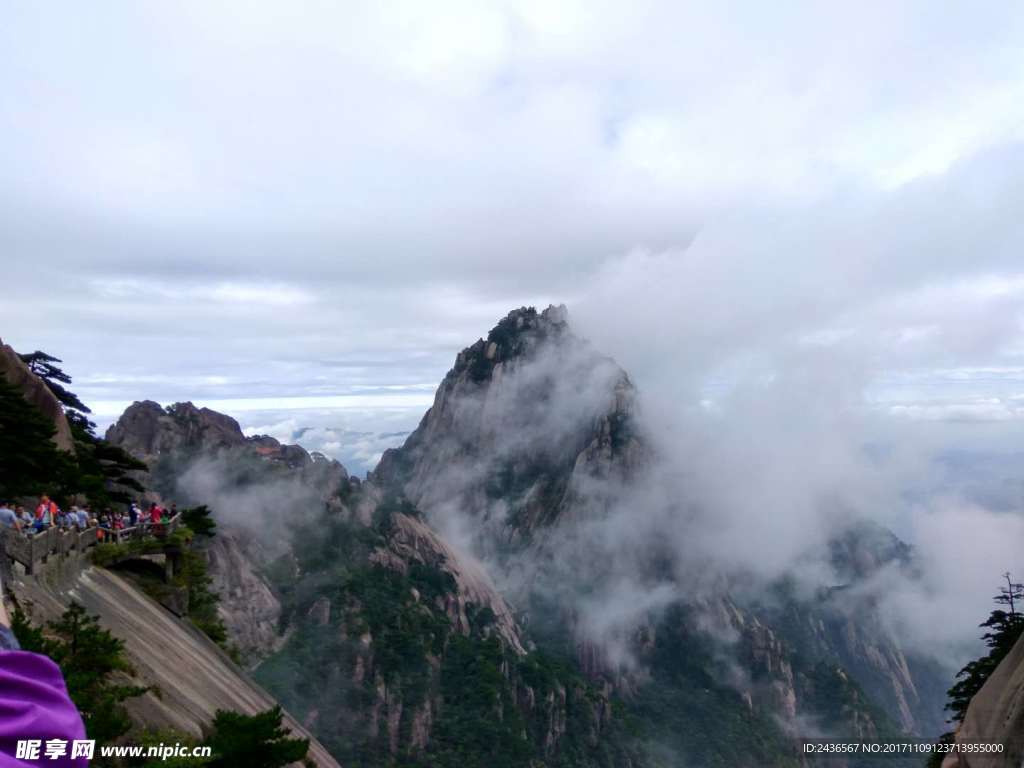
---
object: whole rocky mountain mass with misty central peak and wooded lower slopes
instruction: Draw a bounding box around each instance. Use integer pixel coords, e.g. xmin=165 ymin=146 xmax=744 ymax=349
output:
xmin=101 ymin=307 xmax=945 ymax=768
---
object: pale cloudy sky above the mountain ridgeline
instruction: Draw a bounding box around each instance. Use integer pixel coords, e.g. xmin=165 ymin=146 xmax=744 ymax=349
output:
xmin=6 ymin=0 xmax=1024 ymax=482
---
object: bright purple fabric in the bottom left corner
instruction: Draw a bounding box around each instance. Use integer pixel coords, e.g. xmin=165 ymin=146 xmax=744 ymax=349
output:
xmin=0 ymin=650 xmax=89 ymax=768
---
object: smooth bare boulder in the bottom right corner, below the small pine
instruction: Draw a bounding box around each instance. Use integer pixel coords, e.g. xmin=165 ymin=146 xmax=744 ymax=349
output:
xmin=943 ymin=637 xmax=1024 ymax=768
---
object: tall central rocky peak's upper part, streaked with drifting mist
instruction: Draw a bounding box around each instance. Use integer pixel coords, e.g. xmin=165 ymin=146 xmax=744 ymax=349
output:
xmin=374 ymin=306 xmax=643 ymax=552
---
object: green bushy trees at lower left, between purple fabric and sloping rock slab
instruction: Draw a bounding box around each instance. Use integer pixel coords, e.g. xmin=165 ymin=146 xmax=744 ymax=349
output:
xmin=11 ymin=603 xmax=147 ymax=753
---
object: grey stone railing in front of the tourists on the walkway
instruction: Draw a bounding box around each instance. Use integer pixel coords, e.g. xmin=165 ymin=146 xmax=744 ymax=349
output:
xmin=0 ymin=513 xmax=181 ymax=574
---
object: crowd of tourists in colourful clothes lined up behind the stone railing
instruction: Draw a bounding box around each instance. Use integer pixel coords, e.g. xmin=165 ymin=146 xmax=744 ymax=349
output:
xmin=0 ymin=496 xmax=177 ymax=536
